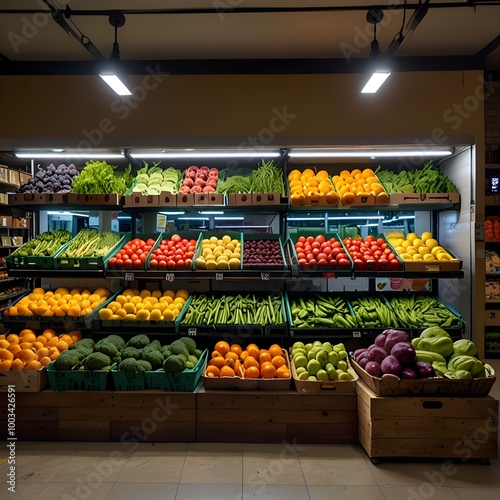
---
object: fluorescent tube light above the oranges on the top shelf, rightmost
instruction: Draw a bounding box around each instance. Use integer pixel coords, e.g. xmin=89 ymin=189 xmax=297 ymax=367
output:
xmin=290 ymin=149 xmax=452 ymax=158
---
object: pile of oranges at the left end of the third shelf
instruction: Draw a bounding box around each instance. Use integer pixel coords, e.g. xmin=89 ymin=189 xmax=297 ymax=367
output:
xmin=8 ymin=287 xmax=111 ymax=318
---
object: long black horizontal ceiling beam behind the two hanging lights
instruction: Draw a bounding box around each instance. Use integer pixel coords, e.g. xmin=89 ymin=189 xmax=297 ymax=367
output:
xmin=2 ymin=56 xmax=484 ymax=76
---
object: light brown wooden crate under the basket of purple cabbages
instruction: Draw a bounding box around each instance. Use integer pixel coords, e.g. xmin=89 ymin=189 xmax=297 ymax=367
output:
xmin=357 ymin=381 xmax=498 ymax=459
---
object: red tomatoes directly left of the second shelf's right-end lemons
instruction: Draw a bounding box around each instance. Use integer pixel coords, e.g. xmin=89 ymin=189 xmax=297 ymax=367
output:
xmin=343 ymin=236 xmax=403 ymax=271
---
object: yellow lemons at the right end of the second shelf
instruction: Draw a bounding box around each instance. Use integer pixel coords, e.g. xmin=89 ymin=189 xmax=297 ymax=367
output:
xmin=388 ymin=231 xmax=457 ymax=262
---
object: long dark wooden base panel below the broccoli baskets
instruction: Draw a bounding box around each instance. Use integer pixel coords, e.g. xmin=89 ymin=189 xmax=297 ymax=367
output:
xmin=0 ymin=390 xmax=196 ymax=442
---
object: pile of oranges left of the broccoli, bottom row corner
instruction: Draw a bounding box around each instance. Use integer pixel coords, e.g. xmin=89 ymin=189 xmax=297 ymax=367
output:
xmin=0 ymin=328 xmax=82 ymax=370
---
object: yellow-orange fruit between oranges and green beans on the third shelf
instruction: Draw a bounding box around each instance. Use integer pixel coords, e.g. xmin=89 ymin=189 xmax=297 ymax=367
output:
xmin=99 ymin=288 xmax=189 ymax=321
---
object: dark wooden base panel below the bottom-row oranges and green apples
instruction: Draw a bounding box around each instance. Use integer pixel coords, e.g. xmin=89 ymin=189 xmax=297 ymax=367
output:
xmin=196 ymin=388 xmax=358 ymax=444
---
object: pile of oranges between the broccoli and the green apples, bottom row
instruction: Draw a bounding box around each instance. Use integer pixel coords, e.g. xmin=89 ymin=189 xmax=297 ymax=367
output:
xmin=205 ymin=340 xmax=290 ymax=379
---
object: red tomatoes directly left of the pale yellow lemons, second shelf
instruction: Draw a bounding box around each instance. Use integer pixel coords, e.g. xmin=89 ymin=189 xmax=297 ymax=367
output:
xmin=149 ymin=234 xmax=196 ymax=270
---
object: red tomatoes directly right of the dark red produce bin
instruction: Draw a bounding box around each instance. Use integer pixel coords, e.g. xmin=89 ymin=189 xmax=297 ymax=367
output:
xmin=295 ymin=234 xmax=351 ymax=269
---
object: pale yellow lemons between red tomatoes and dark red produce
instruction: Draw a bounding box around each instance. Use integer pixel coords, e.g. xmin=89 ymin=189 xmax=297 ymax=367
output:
xmin=194 ymin=234 xmax=241 ymax=271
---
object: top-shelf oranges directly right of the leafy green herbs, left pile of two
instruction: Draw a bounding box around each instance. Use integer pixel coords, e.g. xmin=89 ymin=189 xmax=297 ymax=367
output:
xmin=288 ymin=168 xmax=339 ymax=206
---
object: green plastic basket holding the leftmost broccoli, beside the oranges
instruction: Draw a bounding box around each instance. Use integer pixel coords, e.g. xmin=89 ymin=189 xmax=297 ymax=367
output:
xmin=47 ymin=361 xmax=110 ymax=391
